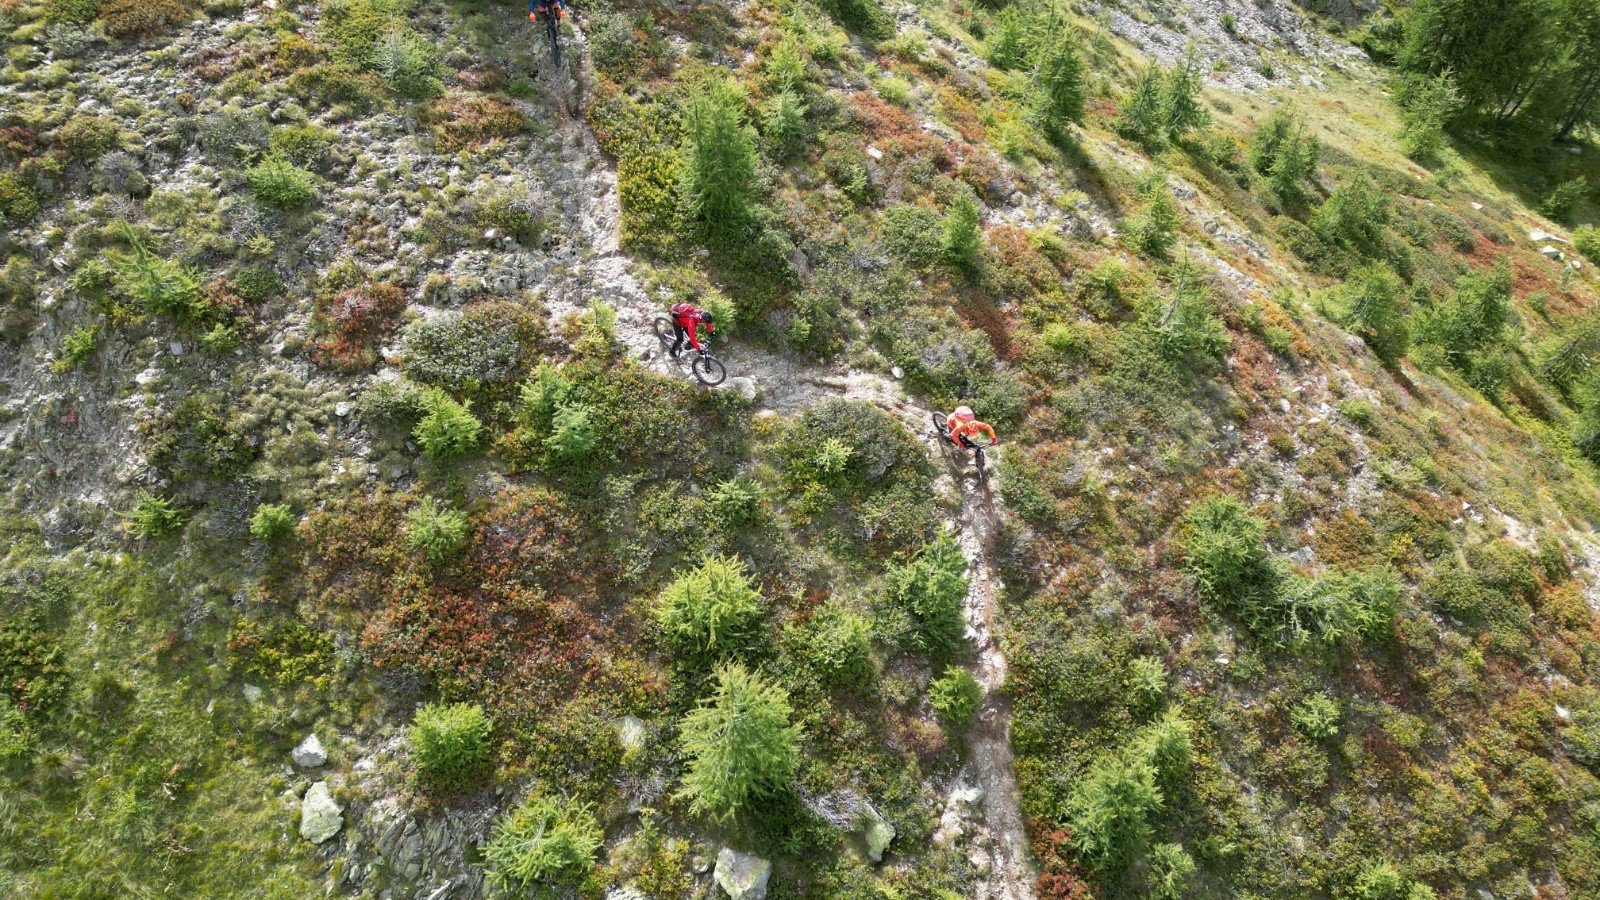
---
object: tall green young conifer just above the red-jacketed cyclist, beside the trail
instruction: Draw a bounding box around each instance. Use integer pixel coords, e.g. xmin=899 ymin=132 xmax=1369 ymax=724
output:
xmin=678 ymin=77 xmax=757 ymax=231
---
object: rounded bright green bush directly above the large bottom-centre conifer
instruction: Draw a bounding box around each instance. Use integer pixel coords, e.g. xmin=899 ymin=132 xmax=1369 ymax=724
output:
xmin=654 ymin=556 xmax=762 ymax=668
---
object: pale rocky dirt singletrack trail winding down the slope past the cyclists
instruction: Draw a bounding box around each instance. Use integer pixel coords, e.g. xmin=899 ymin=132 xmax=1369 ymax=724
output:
xmin=524 ymin=22 xmax=1035 ymax=900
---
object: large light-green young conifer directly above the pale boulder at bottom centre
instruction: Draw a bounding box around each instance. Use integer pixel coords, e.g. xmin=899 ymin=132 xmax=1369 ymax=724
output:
xmin=682 ymin=663 xmax=800 ymax=820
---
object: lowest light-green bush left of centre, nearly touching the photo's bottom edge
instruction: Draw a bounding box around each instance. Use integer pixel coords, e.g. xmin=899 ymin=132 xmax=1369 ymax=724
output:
xmin=483 ymin=794 xmax=605 ymax=897
